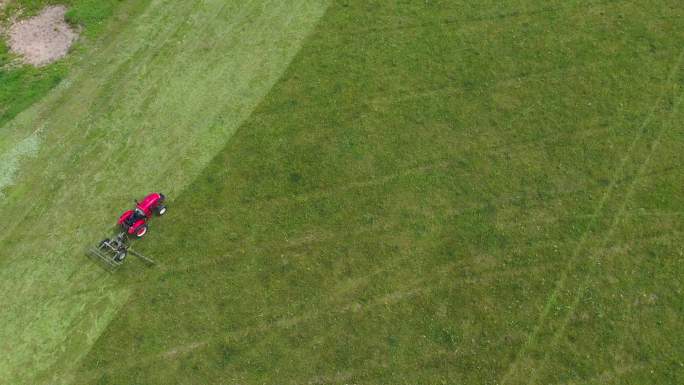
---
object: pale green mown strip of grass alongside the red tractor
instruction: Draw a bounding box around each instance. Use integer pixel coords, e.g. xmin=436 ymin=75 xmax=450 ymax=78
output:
xmin=0 ymin=0 xmax=328 ymax=384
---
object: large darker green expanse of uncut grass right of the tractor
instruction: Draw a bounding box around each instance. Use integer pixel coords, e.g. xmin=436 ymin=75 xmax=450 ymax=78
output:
xmin=72 ymin=1 xmax=684 ymax=384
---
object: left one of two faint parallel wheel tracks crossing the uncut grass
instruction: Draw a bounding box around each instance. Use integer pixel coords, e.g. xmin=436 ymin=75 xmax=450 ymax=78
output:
xmin=501 ymin=51 xmax=684 ymax=384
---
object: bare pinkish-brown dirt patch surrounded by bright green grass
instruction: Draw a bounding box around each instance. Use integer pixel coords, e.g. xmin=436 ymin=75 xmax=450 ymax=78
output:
xmin=7 ymin=5 xmax=78 ymax=67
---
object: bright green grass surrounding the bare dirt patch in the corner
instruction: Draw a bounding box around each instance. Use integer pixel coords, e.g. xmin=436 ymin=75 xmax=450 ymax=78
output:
xmin=0 ymin=0 xmax=125 ymax=126
